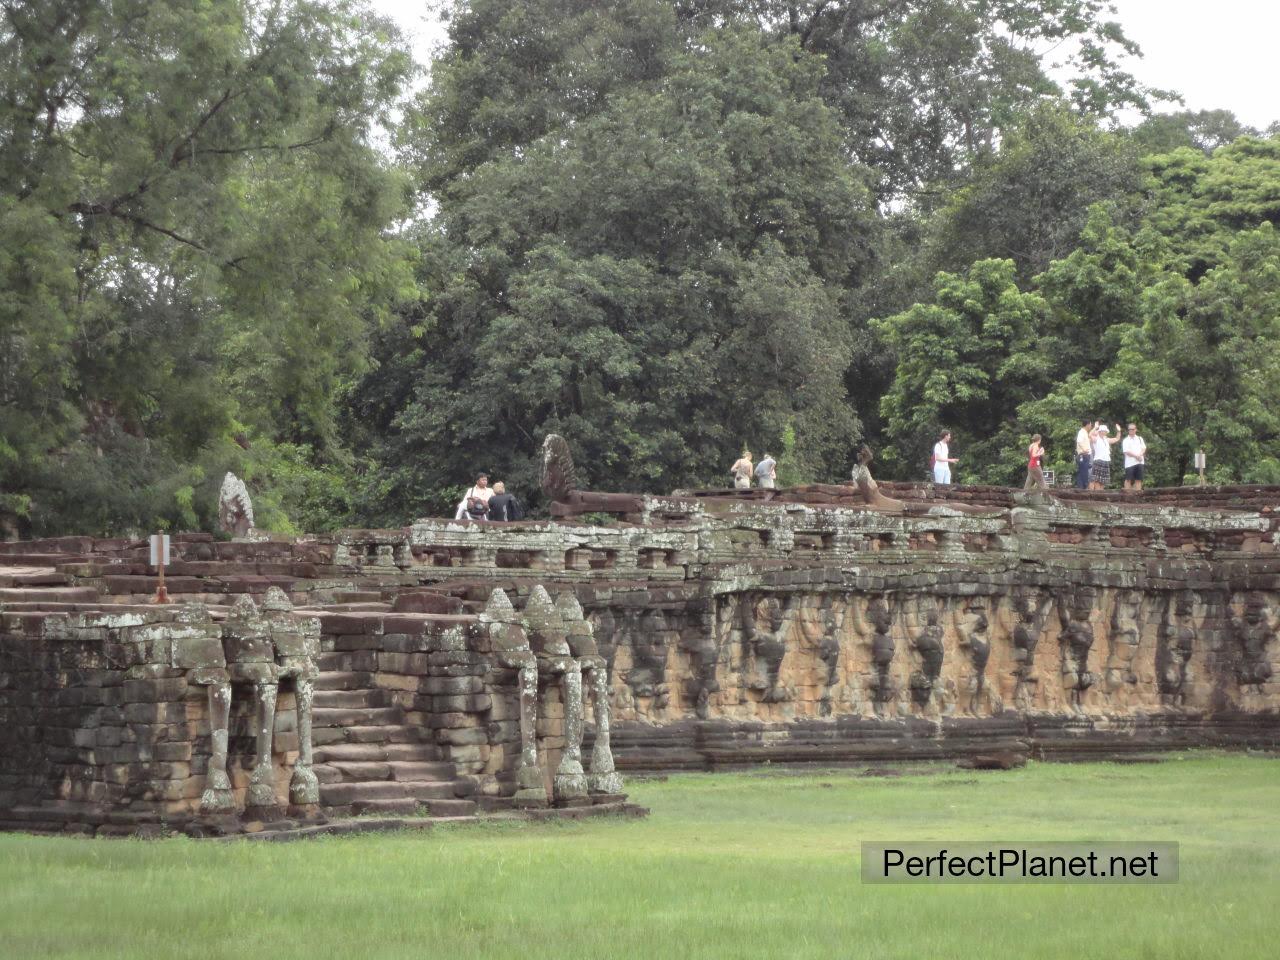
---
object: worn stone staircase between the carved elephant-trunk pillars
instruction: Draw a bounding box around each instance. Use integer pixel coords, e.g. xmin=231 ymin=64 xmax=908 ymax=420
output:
xmin=311 ymin=653 xmax=476 ymax=817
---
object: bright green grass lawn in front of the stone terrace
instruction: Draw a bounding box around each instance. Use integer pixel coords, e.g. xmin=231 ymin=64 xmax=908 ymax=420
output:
xmin=0 ymin=754 xmax=1280 ymax=960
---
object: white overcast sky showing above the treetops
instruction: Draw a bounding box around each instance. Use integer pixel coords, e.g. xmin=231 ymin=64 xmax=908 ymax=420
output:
xmin=371 ymin=0 xmax=1280 ymax=128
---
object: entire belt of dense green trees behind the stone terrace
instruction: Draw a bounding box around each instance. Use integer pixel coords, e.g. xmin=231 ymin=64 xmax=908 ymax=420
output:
xmin=0 ymin=0 xmax=1280 ymax=534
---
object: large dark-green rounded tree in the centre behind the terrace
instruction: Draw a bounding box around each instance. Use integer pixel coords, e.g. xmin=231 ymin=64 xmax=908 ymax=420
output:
xmin=360 ymin=11 xmax=872 ymax=514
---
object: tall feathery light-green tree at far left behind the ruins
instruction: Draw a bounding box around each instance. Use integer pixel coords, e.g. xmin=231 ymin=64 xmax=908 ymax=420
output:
xmin=0 ymin=0 xmax=411 ymax=531
